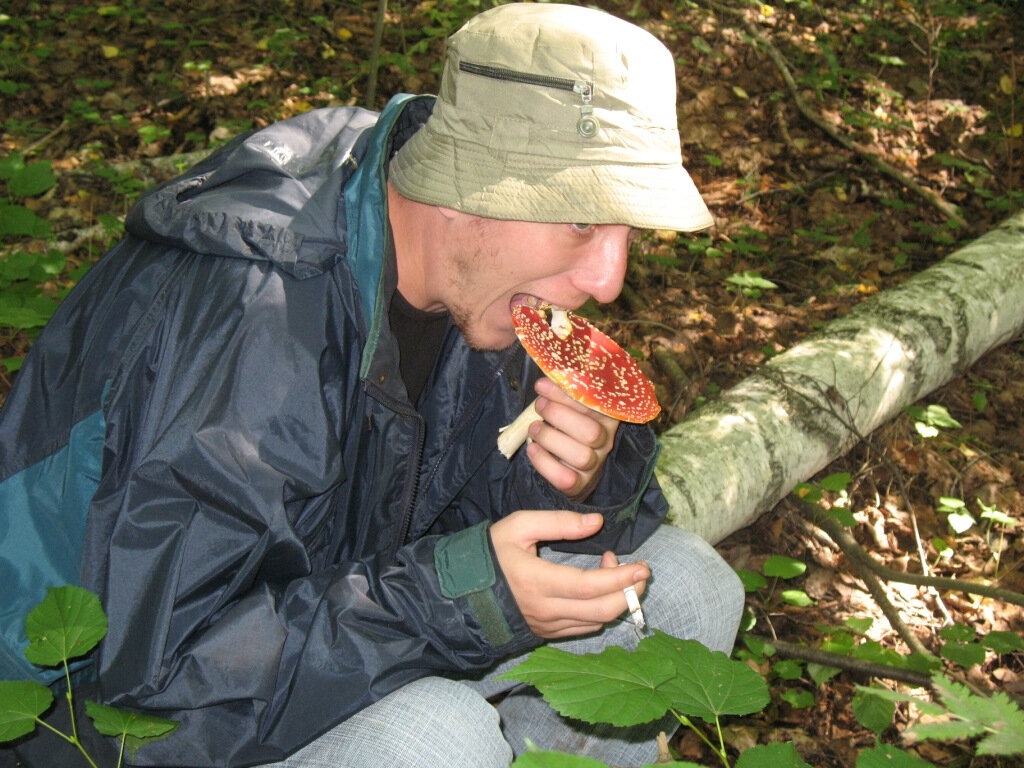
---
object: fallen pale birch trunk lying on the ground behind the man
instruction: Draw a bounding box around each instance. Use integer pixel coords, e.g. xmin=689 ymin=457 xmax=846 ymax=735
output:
xmin=657 ymin=212 xmax=1024 ymax=543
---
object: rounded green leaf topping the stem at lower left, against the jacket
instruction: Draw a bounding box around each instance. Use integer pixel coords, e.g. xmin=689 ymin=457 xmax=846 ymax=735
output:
xmin=25 ymin=587 xmax=106 ymax=667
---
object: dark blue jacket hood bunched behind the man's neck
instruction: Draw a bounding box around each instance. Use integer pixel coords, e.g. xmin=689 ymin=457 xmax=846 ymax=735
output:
xmin=125 ymin=104 xmax=382 ymax=278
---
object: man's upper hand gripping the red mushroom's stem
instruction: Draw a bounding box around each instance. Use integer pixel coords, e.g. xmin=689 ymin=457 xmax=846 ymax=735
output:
xmin=526 ymin=377 xmax=618 ymax=501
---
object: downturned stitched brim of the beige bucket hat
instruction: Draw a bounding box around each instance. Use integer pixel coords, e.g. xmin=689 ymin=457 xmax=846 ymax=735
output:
xmin=389 ymin=124 xmax=715 ymax=231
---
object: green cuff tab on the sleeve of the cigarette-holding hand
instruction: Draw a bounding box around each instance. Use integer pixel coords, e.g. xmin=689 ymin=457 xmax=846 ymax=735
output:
xmin=434 ymin=521 xmax=532 ymax=648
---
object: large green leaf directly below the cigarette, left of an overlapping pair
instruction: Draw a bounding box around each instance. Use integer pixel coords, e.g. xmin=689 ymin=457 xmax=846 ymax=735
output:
xmin=499 ymin=646 xmax=676 ymax=726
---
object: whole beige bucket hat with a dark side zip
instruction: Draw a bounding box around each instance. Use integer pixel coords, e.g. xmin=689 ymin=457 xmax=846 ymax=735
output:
xmin=389 ymin=3 xmax=714 ymax=231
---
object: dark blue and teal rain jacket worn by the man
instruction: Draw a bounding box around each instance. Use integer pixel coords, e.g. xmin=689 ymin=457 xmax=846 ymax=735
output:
xmin=0 ymin=96 xmax=666 ymax=766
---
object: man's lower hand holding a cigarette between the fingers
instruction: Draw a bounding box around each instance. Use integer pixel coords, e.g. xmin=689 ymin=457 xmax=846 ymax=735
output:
xmin=490 ymin=510 xmax=650 ymax=639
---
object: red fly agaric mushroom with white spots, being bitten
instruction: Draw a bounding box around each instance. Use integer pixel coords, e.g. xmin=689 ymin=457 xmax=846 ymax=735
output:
xmin=498 ymin=303 xmax=662 ymax=459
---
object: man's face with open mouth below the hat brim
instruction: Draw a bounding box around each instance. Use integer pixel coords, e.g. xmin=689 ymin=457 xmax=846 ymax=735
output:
xmin=428 ymin=214 xmax=632 ymax=349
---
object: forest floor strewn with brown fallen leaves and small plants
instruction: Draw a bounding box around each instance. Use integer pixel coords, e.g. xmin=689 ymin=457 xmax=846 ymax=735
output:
xmin=0 ymin=0 xmax=1024 ymax=766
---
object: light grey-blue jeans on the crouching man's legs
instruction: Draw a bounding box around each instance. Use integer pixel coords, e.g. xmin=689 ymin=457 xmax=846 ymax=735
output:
xmin=268 ymin=526 xmax=743 ymax=768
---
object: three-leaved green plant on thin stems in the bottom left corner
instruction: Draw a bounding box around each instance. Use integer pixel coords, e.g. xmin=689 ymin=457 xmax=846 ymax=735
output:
xmin=0 ymin=587 xmax=178 ymax=768
